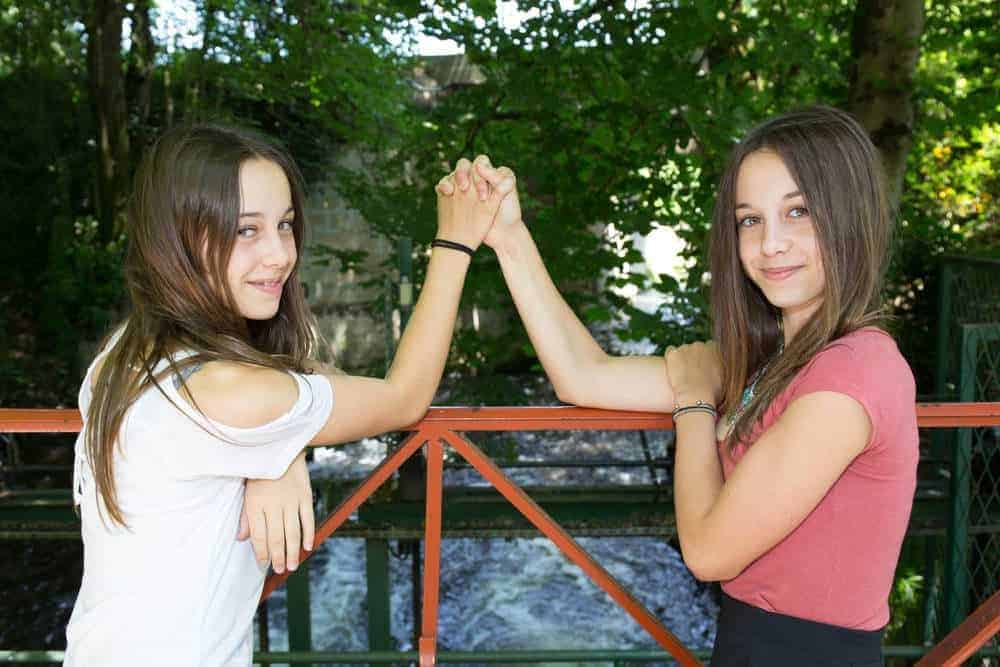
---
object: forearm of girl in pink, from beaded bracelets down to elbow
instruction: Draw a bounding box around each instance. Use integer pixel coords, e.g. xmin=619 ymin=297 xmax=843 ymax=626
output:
xmin=674 ymin=413 xmax=729 ymax=581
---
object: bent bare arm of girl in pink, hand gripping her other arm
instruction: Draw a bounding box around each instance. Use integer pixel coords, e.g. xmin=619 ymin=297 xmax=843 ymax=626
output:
xmin=668 ymin=344 xmax=871 ymax=581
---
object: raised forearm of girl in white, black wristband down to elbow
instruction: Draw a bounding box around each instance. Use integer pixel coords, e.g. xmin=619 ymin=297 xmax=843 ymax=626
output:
xmin=386 ymin=248 xmax=471 ymax=423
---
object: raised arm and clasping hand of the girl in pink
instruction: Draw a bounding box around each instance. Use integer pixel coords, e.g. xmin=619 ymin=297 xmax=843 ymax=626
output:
xmin=455 ymin=162 xmax=673 ymax=412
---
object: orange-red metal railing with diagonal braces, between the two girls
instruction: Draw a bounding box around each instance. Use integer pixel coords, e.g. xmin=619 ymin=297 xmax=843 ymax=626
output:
xmin=0 ymin=403 xmax=1000 ymax=667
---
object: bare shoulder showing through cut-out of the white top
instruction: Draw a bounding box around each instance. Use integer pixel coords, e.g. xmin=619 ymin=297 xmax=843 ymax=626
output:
xmin=181 ymin=361 xmax=298 ymax=428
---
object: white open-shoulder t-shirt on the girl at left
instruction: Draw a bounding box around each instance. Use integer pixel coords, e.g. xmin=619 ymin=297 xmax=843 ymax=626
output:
xmin=64 ymin=341 xmax=333 ymax=667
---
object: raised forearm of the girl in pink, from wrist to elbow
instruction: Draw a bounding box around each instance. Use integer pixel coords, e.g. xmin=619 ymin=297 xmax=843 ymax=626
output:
xmin=496 ymin=226 xmax=607 ymax=400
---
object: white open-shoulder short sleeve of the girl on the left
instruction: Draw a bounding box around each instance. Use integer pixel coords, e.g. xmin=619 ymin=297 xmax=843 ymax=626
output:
xmin=157 ymin=373 xmax=333 ymax=479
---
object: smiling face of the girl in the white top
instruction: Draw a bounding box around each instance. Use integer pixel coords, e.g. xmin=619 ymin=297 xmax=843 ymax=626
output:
xmin=226 ymin=159 xmax=298 ymax=320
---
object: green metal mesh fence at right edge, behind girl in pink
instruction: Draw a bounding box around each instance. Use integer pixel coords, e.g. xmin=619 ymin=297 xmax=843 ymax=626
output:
xmin=923 ymin=257 xmax=1000 ymax=647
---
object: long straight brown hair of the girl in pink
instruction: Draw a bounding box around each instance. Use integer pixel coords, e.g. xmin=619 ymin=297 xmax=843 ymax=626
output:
xmin=709 ymin=106 xmax=893 ymax=448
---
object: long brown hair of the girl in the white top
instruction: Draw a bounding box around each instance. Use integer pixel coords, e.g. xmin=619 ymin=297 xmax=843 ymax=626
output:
xmin=85 ymin=124 xmax=316 ymax=525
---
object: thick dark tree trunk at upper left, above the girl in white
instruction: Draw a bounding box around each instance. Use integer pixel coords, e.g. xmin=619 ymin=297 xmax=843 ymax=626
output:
xmin=85 ymin=0 xmax=129 ymax=242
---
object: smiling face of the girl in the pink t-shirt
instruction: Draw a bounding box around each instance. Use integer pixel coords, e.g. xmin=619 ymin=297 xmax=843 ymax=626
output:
xmin=736 ymin=150 xmax=826 ymax=338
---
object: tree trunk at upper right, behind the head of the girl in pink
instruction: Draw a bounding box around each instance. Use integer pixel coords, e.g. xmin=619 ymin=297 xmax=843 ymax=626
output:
xmin=848 ymin=0 xmax=924 ymax=207
